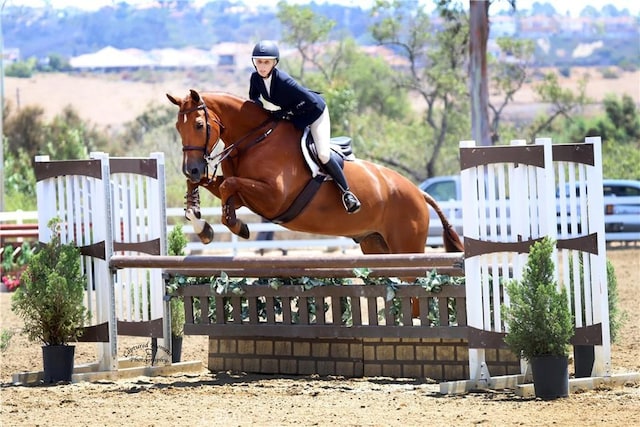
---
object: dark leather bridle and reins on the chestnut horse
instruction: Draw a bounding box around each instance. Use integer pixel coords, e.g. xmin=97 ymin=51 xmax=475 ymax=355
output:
xmin=178 ymin=102 xmax=278 ymax=179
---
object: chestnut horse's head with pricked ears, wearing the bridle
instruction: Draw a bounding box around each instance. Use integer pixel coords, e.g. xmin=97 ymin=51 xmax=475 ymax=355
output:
xmin=167 ymin=89 xmax=223 ymax=182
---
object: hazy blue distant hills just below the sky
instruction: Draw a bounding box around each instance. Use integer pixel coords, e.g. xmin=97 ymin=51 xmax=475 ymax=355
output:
xmin=3 ymin=0 xmax=640 ymax=67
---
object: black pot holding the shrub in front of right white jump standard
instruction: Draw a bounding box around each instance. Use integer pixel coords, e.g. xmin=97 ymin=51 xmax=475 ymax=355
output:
xmin=531 ymin=356 xmax=569 ymax=399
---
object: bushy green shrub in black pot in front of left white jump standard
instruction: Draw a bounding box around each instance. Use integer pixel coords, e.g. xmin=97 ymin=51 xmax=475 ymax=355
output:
xmin=11 ymin=218 xmax=88 ymax=383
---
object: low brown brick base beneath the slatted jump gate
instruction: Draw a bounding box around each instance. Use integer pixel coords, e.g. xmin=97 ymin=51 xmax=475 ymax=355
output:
xmin=208 ymin=338 xmax=520 ymax=381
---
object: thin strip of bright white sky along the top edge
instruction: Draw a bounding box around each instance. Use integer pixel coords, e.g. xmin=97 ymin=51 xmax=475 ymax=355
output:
xmin=0 ymin=0 xmax=640 ymax=16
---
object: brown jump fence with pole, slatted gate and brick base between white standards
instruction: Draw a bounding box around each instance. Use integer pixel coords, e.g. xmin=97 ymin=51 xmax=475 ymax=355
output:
xmin=109 ymin=252 xmax=504 ymax=379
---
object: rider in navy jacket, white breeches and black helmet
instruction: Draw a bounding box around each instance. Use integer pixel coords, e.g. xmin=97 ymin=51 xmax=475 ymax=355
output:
xmin=249 ymin=41 xmax=360 ymax=213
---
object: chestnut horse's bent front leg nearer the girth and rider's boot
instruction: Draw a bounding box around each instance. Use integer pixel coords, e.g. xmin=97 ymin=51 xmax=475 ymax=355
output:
xmin=220 ymin=177 xmax=274 ymax=239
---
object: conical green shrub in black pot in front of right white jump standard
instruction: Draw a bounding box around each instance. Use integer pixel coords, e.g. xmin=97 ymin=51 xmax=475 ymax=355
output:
xmin=503 ymin=237 xmax=574 ymax=399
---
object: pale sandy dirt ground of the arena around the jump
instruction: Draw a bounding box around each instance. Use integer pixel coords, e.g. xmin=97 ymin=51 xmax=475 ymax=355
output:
xmin=0 ymin=245 xmax=640 ymax=426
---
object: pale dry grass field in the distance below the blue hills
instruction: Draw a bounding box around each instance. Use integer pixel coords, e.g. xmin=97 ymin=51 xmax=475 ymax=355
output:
xmin=5 ymin=68 xmax=640 ymax=128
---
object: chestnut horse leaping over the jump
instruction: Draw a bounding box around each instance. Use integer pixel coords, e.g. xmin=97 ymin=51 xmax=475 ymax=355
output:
xmin=167 ymin=90 xmax=463 ymax=254
